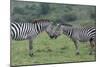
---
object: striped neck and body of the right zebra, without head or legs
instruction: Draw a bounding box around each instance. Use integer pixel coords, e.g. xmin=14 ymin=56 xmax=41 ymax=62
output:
xmin=63 ymin=27 xmax=96 ymax=42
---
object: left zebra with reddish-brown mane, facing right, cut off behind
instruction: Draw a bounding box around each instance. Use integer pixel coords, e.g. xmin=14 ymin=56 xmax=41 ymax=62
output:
xmin=10 ymin=19 xmax=54 ymax=57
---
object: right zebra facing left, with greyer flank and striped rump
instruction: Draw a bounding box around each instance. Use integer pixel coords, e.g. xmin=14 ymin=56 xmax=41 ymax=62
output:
xmin=53 ymin=24 xmax=96 ymax=55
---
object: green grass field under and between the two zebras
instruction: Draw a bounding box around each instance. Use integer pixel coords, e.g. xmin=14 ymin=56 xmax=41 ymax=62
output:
xmin=11 ymin=33 xmax=96 ymax=66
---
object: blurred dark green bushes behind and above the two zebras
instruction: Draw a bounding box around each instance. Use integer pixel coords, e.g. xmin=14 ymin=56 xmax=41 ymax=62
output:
xmin=11 ymin=0 xmax=96 ymax=25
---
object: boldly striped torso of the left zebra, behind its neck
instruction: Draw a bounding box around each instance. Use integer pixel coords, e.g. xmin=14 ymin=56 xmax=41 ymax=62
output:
xmin=11 ymin=23 xmax=34 ymax=40
